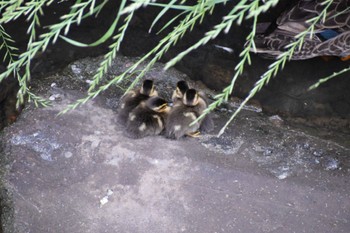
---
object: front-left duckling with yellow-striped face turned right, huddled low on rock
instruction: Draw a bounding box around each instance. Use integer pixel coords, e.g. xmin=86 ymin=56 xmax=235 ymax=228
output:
xmin=126 ymin=96 xmax=170 ymax=138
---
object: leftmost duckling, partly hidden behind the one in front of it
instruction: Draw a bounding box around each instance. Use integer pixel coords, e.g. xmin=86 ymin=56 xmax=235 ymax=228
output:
xmin=118 ymin=79 xmax=158 ymax=124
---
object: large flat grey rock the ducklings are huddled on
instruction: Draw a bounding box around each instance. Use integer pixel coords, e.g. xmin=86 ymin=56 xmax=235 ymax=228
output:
xmin=0 ymin=57 xmax=350 ymax=233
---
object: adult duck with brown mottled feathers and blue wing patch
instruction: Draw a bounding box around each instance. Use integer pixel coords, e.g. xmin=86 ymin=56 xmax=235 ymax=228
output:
xmin=252 ymin=0 xmax=350 ymax=60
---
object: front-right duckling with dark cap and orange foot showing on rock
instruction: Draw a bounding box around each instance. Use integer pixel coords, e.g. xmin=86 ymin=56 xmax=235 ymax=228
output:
xmin=165 ymin=89 xmax=207 ymax=139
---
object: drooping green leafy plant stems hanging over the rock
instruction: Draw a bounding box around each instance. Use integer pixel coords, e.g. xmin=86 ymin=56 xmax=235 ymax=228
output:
xmin=0 ymin=0 xmax=350 ymax=135
